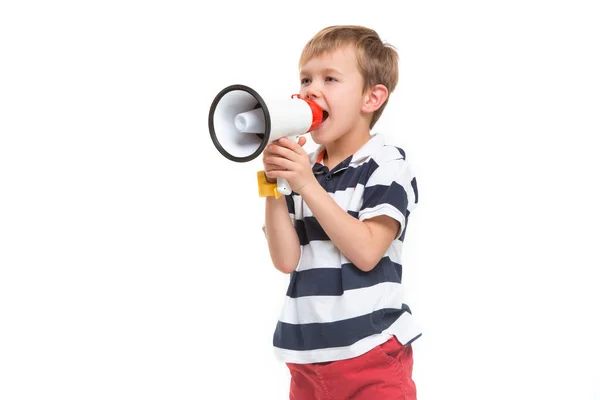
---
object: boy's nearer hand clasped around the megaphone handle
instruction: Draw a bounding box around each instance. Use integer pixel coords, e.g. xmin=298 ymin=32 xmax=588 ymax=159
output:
xmin=263 ymin=136 xmax=316 ymax=193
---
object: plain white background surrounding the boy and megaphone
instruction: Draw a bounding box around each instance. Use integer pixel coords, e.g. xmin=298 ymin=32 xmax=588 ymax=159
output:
xmin=0 ymin=0 xmax=600 ymax=400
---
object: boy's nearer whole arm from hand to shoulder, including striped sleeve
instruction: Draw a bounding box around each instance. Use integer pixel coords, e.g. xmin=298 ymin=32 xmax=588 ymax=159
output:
xmin=265 ymin=138 xmax=417 ymax=271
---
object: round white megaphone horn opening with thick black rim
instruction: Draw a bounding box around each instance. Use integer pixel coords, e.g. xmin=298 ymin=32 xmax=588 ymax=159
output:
xmin=208 ymin=85 xmax=271 ymax=162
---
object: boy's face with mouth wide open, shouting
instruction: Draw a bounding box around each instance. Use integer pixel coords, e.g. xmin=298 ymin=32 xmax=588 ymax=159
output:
xmin=300 ymin=46 xmax=365 ymax=145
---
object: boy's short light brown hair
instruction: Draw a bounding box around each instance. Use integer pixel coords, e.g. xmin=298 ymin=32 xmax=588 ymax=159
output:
xmin=299 ymin=25 xmax=398 ymax=128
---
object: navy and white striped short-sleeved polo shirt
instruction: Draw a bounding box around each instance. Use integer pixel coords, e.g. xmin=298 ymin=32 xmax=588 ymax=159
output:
xmin=273 ymin=134 xmax=421 ymax=364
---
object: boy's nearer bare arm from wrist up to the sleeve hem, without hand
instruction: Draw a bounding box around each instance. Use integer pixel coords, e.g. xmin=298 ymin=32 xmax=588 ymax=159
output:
xmin=300 ymin=183 xmax=400 ymax=272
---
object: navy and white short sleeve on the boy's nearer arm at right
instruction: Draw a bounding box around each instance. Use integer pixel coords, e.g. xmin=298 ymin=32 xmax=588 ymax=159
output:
xmin=358 ymin=158 xmax=418 ymax=239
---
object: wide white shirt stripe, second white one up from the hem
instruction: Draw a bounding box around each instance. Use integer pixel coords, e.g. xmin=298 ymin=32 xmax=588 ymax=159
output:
xmin=279 ymin=282 xmax=404 ymax=324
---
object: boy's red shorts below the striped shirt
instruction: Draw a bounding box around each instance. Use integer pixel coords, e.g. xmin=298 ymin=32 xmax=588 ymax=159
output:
xmin=287 ymin=336 xmax=417 ymax=400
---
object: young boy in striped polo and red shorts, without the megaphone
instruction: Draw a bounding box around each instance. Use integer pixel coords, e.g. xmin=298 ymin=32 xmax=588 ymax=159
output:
xmin=263 ymin=26 xmax=420 ymax=400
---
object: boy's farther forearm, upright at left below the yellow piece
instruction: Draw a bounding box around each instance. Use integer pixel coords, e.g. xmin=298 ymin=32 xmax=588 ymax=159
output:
xmin=265 ymin=196 xmax=300 ymax=274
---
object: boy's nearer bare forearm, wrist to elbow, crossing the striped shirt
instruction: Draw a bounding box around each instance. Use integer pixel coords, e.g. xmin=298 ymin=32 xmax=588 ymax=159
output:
xmin=301 ymin=183 xmax=385 ymax=271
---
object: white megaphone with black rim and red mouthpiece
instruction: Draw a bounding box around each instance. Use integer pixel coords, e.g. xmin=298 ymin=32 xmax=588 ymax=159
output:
xmin=208 ymin=84 xmax=323 ymax=197
